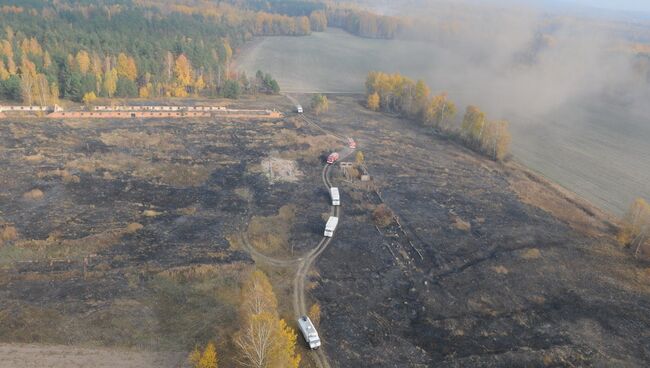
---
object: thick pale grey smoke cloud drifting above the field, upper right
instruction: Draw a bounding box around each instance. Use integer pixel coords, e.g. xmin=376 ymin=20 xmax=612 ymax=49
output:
xmin=394 ymin=2 xmax=646 ymax=116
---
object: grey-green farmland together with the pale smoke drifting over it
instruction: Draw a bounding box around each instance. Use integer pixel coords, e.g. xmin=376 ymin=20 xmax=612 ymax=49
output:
xmin=239 ymin=2 xmax=650 ymax=214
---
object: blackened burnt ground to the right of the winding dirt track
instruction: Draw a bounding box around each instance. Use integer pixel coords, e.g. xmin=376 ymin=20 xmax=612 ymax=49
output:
xmin=302 ymin=97 xmax=650 ymax=367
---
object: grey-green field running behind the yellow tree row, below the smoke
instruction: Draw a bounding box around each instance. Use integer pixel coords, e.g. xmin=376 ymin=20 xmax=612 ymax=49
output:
xmin=238 ymin=29 xmax=650 ymax=215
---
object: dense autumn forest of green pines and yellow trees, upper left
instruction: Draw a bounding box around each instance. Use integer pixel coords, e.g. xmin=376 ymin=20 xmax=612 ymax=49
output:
xmin=0 ymin=0 xmax=292 ymax=104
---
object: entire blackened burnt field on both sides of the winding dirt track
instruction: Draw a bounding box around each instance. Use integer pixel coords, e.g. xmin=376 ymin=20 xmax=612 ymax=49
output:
xmin=0 ymin=96 xmax=650 ymax=367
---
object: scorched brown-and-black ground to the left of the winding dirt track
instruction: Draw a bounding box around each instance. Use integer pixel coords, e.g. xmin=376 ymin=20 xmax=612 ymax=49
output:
xmin=0 ymin=97 xmax=330 ymax=365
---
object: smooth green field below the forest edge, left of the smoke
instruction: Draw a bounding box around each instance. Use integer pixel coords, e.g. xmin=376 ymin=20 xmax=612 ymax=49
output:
xmin=238 ymin=28 xmax=450 ymax=93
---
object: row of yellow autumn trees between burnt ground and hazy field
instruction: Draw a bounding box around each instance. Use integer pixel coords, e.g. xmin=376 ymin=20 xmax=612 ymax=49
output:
xmin=366 ymin=72 xmax=511 ymax=160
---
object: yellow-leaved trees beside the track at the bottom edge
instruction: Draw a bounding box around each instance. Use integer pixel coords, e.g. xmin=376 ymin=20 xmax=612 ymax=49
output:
xmin=188 ymin=270 xmax=300 ymax=368
